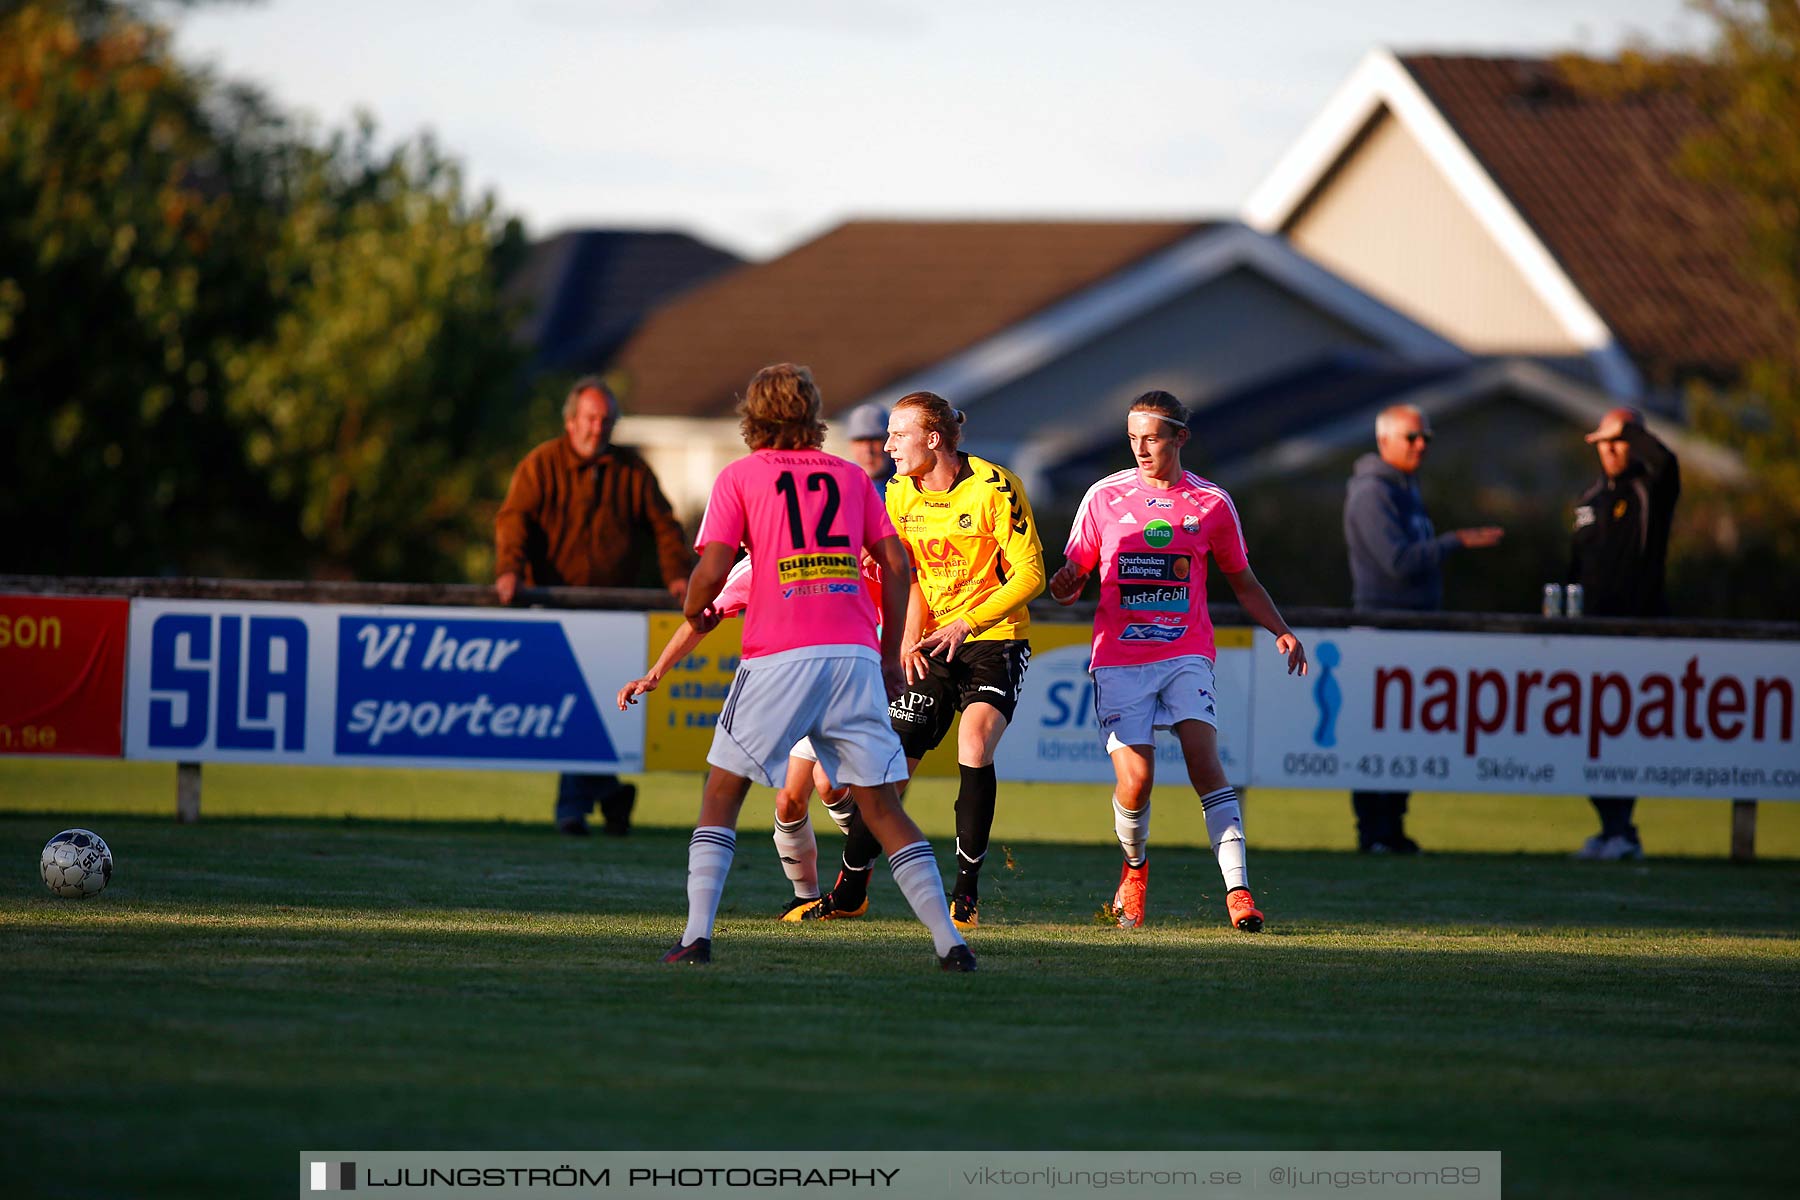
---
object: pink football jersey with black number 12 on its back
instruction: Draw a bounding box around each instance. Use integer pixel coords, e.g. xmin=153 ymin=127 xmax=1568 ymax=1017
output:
xmin=695 ymin=450 xmax=895 ymax=658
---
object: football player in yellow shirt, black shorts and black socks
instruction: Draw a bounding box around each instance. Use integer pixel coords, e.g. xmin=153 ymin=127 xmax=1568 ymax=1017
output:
xmin=803 ymin=392 xmax=1044 ymax=930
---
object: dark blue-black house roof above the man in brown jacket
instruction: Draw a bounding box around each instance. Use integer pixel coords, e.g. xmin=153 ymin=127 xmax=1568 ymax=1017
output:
xmin=502 ymin=228 xmax=742 ymax=371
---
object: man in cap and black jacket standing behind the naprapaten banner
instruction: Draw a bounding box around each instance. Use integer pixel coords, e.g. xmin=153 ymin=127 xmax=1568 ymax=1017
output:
xmin=1566 ymin=408 xmax=1681 ymax=862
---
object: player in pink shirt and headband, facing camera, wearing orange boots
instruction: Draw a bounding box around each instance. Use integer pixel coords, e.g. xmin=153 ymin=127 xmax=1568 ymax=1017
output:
xmin=1049 ymin=392 xmax=1307 ymax=934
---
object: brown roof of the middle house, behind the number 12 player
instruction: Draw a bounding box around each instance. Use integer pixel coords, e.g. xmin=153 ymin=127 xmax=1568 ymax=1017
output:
xmin=610 ymin=221 xmax=1206 ymax=416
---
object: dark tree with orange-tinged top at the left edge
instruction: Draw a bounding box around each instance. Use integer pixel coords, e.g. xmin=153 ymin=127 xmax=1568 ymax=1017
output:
xmin=0 ymin=4 xmax=293 ymax=574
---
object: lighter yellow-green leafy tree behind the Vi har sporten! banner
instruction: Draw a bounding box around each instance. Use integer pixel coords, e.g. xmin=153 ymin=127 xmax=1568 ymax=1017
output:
xmin=225 ymin=121 xmax=520 ymax=579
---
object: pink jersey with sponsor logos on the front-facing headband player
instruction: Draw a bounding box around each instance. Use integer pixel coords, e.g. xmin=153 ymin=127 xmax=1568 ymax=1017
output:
xmin=1064 ymin=468 xmax=1249 ymax=667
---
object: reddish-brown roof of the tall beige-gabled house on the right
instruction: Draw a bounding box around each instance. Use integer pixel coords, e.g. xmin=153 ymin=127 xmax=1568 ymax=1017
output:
xmin=1400 ymin=54 xmax=1782 ymax=385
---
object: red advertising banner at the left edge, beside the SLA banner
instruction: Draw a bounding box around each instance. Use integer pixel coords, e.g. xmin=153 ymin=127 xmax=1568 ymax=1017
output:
xmin=0 ymin=596 xmax=131 ymax=757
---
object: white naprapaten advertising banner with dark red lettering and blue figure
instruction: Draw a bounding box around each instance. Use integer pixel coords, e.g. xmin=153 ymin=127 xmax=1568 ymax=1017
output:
xmin=1251 ymin=630 xmax=1800 ymax=801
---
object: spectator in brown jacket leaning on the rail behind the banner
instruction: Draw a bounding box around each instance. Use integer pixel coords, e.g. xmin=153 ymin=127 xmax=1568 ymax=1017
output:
xmin=493 ymin=376 xmax=693 ymax=837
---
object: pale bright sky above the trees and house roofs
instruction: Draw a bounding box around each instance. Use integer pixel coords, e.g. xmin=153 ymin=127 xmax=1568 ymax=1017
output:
xmin=171 ymin=0 xmax=1706 ymax=257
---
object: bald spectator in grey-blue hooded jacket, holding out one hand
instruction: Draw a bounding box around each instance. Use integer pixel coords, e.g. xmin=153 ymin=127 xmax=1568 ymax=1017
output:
xmin=1345 ymin=405 xmax=1503 ymax=855
